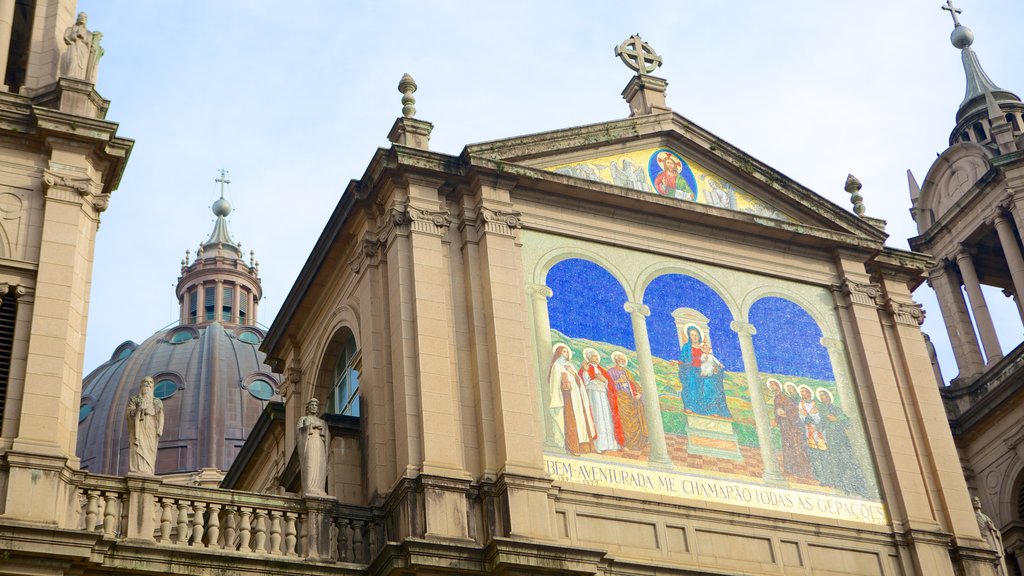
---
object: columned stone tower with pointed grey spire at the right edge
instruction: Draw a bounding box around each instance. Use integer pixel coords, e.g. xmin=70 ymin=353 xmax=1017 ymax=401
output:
xmin=910 ymin=4 xmax=1024 ymax=574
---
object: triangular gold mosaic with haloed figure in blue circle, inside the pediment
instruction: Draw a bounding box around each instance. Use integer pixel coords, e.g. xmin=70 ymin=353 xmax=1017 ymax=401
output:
xmin=546 ymin=148 xmax=793 ymax=221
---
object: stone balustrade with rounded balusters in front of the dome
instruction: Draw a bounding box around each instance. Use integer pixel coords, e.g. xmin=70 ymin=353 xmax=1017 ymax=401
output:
xmin=78 ymin=475 xmax=384 ymax=564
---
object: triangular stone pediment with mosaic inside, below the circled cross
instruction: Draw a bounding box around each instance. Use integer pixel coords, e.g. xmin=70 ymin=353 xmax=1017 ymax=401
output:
xmin=467 ymin=112 xmax=886 ymax=241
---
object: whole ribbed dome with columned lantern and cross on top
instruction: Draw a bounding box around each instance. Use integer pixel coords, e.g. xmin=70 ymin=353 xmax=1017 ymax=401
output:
xmin=78 ymin=186 xmax=281 ymax=486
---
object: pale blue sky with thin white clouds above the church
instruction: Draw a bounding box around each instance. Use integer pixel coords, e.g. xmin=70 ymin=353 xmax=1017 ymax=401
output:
xmin=79 ymin=0 xmax=1024 ymax=379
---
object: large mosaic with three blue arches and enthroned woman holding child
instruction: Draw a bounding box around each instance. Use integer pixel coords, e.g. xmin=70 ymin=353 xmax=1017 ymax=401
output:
xmin=523 ymin=232 xmax=888 ymax=525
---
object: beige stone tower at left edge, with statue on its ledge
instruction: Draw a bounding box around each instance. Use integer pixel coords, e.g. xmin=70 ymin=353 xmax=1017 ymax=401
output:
xmin=0 ymin=0 xmax=133 ymax=526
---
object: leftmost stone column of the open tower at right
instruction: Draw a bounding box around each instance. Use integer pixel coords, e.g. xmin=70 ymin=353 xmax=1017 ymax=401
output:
xmin=928 ymin=260 xmax=985 ymax=378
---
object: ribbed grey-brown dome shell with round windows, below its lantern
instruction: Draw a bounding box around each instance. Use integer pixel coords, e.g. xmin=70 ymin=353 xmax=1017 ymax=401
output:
xmin=78 ymin=322 xmax=281 ymax=476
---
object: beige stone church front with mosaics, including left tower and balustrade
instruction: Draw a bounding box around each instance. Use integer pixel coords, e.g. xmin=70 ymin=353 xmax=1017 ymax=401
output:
xmin=0 ymin=0 xmax=997 ymax=576
